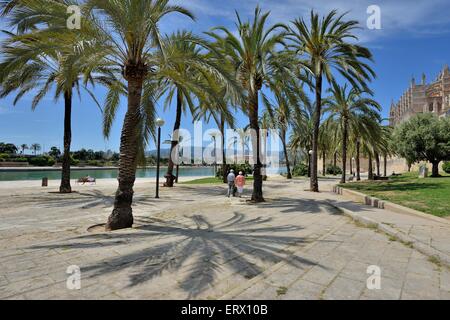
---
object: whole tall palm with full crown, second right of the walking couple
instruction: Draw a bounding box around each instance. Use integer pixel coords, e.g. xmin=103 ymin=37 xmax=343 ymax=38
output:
xmin=289 ymin=10 xmax=375 ymax=192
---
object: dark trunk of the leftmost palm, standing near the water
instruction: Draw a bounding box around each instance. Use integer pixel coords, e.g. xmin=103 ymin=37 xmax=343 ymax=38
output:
xmin=59 ymin=92 xmax=72 ymax=193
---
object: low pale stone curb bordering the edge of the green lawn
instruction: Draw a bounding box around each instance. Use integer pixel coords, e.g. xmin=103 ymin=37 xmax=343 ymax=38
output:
xmin=333 ymin=185 xmax=450 ymax=225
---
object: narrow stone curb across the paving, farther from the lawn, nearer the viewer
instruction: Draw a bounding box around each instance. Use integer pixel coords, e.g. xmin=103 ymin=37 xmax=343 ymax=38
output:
xmin=329 ymin=202 xmax=450 ymax=268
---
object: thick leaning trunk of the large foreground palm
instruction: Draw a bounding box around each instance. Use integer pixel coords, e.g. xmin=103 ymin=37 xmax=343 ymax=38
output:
xmin=106 ymin=74 xmax=145 ymax=230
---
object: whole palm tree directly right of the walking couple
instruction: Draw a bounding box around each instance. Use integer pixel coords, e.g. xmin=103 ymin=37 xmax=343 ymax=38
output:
xmin=208 ymin=7 xmax=285 ymax=202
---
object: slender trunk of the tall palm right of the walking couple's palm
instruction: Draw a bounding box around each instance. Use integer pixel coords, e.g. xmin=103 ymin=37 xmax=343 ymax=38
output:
xmin=310 ymin=74 xmax=322 ymax=192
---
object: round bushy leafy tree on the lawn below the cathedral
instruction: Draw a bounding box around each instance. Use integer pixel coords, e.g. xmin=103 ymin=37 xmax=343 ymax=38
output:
xmin=394 ymin=113 xmax=450 ymax=177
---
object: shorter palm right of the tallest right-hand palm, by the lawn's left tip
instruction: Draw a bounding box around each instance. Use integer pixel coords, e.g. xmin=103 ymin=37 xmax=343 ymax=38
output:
xmin=325 ymin=82 xmax=381 ymax=183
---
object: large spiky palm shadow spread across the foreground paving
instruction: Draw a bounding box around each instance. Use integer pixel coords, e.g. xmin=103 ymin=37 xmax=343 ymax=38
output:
xmin=32 ymin=212 xmax=326 ymax=298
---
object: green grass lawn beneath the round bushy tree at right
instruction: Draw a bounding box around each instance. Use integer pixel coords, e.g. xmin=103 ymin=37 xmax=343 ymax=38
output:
xmin=341 ymin=172 xmax=450 ymax=217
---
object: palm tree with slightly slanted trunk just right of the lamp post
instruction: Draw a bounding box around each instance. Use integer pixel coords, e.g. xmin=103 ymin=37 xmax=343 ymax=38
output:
xmin=158 ymin=31 xmax=237 ymax=187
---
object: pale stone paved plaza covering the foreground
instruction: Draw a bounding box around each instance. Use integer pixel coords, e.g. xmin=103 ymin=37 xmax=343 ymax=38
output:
xmin=0 ymin=179 xmax=450 ymax=299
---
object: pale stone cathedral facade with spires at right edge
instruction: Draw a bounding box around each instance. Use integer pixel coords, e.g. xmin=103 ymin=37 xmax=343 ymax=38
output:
xmin=389 ymin=65 xmax=450 ymax=126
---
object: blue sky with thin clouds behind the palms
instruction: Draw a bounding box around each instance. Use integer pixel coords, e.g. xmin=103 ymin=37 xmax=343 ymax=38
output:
xmin=0 ymin=0 xmax=450 ymax=150
